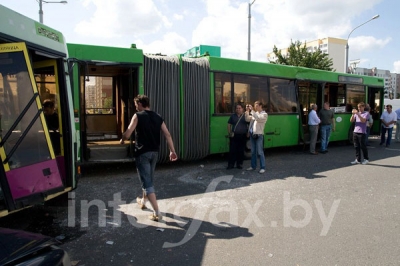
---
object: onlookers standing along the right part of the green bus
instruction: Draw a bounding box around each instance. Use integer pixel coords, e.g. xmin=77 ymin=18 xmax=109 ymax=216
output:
xmin=227 ymin=101 xmax=400 ymax=170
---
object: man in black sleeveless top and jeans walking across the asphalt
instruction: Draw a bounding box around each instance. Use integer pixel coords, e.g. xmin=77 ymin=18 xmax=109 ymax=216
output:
xmin=120 ymin=95 xmax=178 ymax=221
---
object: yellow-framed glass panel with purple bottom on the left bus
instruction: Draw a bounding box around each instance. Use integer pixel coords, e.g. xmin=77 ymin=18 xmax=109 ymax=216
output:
xmin=0 ymin=43 xmax=64 ymax=214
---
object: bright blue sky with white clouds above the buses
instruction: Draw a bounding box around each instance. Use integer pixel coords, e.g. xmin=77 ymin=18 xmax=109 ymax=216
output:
xmin=0 ymin=0 xmax=400 ymax=73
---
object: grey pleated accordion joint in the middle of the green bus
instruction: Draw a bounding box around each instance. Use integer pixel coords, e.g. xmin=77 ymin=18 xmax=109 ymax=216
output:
xmin=144 ymin=55 xmax=211 ymax=162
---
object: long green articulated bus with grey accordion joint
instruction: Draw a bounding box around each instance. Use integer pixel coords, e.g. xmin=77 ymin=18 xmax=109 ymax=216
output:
xmin=67 ymin=44 xmax=384 ymax=163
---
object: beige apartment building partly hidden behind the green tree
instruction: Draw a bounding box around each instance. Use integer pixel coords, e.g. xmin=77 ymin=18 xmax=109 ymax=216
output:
xmin=267 ymin=37 xmax=346 ymax=72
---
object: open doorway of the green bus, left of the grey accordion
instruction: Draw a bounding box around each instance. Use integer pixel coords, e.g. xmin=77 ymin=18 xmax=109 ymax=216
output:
xmin=80 ymin=62 xmax=139 ymax=162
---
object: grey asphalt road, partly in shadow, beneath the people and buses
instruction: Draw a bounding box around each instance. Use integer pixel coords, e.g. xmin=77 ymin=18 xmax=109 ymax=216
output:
xmin=0 ymin=139 xmax=400 ymax=266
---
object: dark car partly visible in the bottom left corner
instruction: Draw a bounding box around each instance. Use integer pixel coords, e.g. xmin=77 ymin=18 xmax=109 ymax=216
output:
xmin=0 ymin=228 xmax=71 ymax=266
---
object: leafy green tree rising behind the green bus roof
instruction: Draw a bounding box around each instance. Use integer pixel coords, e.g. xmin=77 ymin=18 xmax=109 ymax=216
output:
xmin=271 ymin=41 xmax=336 ymax=71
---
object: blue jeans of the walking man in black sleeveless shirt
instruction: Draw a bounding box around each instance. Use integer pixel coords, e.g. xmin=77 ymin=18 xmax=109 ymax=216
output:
xmin=135 ymin=151 xmax=158 ymax=195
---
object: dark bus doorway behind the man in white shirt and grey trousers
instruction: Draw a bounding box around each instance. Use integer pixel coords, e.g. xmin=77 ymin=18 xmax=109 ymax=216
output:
xmin=298 ymin=81 xmax=322 ymax=143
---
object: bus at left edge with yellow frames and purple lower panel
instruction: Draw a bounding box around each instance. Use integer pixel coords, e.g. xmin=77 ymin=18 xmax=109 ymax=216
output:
xmin=0 ymin=5 xmax=79 ymax=217
